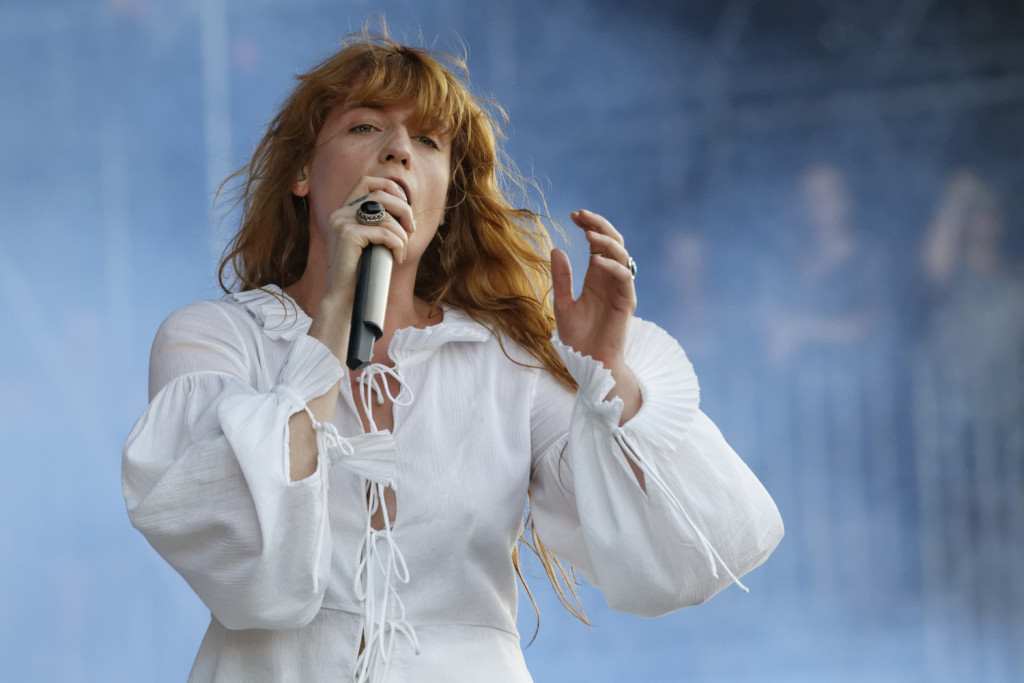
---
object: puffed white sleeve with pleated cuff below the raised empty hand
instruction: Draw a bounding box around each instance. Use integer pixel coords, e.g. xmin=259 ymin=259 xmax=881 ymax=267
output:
xmin=530 ymin=318 xmax=782 ymax=616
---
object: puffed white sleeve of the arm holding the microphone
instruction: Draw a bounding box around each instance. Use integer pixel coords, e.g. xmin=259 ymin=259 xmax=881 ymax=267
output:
xmin=122 ymin=302 xmax=393 ymax=629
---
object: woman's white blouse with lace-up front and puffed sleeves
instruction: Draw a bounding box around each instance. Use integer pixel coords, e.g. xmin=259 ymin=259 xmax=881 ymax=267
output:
xmin=122 ymin=288 xmax=782 ymax=683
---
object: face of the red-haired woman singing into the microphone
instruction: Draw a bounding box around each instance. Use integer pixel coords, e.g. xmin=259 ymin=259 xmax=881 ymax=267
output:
xmin=293 ymin=104 xmax=452 ymax=263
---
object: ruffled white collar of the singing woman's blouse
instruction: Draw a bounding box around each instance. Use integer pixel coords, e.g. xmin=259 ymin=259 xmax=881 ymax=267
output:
xmin=224 ymin=285 xmax=490 ymax=364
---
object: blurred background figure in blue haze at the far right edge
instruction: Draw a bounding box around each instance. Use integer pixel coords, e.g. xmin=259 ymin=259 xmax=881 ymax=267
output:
xmin=912 ymin=168 xmax=1024 ymax=665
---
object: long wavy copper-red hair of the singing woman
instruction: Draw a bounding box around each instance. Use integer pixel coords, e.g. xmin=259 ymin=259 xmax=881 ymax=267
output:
xmin=218 ymin=23 xmax=589 ymax=637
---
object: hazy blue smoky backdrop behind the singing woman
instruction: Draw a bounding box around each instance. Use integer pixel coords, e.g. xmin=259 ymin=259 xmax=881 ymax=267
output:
xmin=0 ymin=0 xmax=1024 ymax=683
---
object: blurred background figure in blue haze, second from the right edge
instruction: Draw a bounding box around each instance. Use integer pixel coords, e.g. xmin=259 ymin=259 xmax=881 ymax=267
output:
xmin=756 ymin=161 xmax=897 ymax=604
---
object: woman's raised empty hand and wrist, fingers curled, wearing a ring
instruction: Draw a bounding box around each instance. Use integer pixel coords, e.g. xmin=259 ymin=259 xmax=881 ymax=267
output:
xmin=551 ymin=211 xmax=640 ymax=423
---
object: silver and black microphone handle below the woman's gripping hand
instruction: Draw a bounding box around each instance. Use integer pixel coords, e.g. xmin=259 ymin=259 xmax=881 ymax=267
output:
xmin=346 ymin=245 xmax=394 ymax=370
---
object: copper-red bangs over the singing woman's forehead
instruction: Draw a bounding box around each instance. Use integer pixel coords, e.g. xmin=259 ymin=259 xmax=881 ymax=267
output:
xmin=345 ymin=45 xmax=476 ymax=135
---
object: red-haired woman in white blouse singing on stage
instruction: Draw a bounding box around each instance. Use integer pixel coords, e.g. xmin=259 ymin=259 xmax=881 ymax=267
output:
xmin=123 ymin=21 xmax=782 ymax=683
